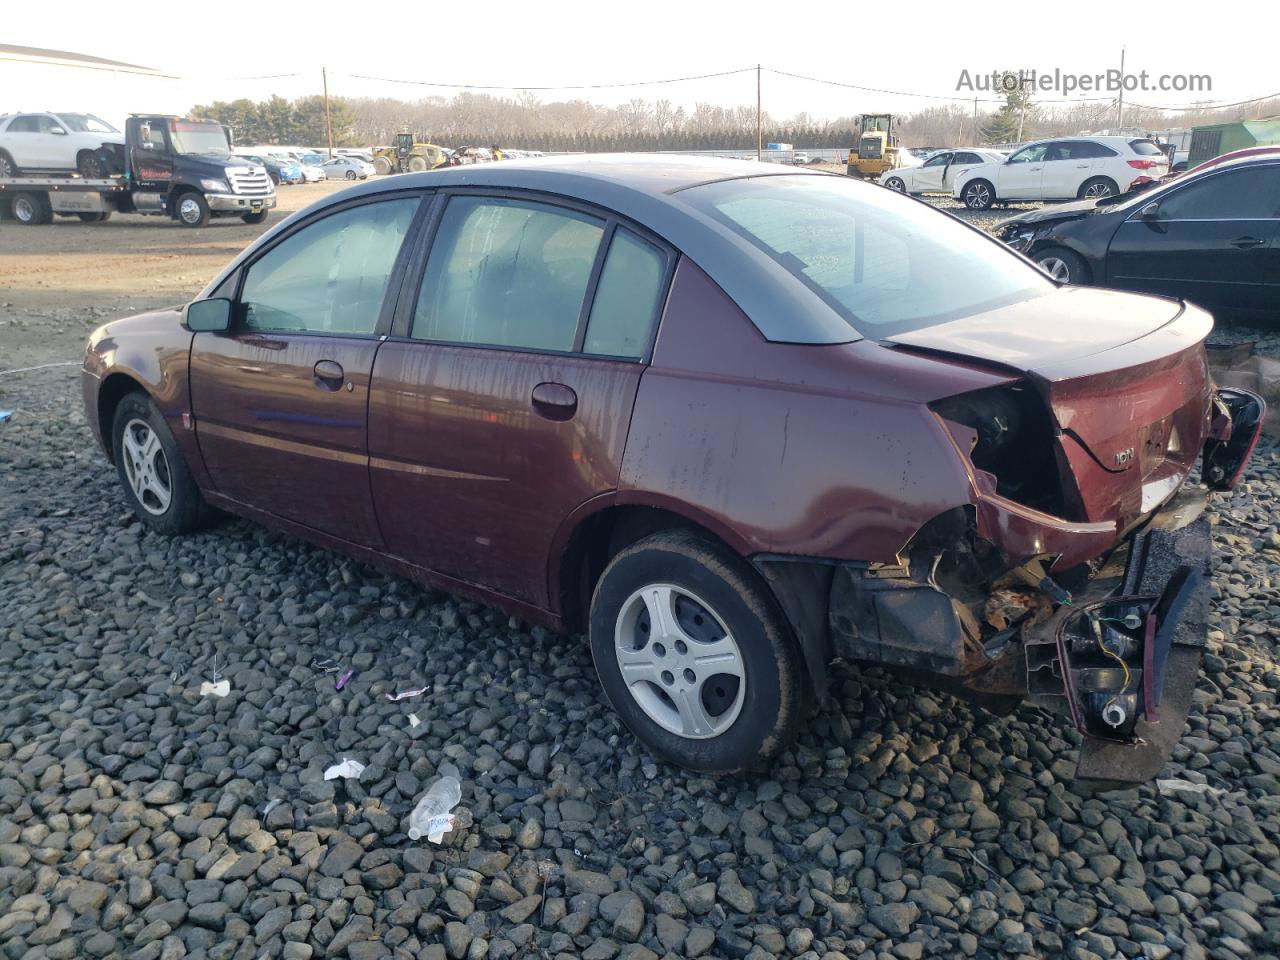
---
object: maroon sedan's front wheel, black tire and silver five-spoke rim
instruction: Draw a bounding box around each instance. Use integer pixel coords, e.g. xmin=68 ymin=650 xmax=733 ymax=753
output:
xmin=111 ymin=393 xmax=212 ymax=535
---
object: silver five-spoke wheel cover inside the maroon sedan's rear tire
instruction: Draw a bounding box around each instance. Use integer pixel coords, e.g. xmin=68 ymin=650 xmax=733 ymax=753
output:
xmin=613 ymin=584 xmax=746 ymax=740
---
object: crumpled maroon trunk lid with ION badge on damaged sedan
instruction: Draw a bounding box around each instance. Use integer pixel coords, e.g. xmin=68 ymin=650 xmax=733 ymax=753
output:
xmin=888 ymin=288 xmax=1213 ymax=527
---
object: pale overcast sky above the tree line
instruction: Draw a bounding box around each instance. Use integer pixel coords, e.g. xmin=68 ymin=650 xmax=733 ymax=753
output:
xmin=0 ymin=0 xmax=1280 ymax=119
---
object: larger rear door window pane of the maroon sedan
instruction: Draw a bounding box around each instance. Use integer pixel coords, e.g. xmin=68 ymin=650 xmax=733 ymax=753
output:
xmin=412 ymin=197 xmax=604 ymax=351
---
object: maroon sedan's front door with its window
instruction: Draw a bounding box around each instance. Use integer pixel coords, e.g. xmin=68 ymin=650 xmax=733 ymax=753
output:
xmin=191 ymin=197 xmax=420 ymax=547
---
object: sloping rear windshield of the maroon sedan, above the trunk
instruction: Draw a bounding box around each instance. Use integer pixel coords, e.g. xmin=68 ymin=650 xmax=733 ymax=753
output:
xmin=680 ymin=174 xmax=1055 ymax=338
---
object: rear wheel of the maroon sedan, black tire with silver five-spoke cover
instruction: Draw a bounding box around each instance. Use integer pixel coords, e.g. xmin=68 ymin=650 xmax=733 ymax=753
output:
xmin=590 ymin=530 xmax=804 ymax=773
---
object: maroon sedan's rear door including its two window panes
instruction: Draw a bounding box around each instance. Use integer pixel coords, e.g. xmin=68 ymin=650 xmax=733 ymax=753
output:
xmin=369 ymin=195 xmax=669 ymax=607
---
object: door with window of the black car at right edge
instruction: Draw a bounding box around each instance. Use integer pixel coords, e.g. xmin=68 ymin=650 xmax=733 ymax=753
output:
xmin=1107 ymin=164 xmax=1280 ymax=311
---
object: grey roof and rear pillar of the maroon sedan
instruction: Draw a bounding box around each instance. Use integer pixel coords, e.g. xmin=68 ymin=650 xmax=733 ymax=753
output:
xmin=212 ymin=154 xmax=860 ymax=343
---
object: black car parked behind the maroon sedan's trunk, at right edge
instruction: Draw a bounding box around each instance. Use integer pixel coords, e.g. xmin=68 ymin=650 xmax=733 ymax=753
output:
xmin=997 ymin=155 xmax=1280 ymax=319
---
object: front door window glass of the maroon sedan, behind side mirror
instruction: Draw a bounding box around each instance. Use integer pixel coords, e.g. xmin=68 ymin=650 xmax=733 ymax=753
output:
xmin=241 ymin=197 xmax=419 ymax=337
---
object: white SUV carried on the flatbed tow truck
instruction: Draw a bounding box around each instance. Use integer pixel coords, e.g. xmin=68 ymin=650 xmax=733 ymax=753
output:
xmin=0 ymin=113 xmax=124 ymax=179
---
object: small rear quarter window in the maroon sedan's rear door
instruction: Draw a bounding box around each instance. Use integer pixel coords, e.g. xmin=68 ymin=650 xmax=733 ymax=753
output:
xmin=582 ymin=227 xmax=667 ymax=360
